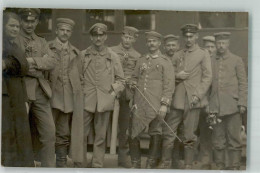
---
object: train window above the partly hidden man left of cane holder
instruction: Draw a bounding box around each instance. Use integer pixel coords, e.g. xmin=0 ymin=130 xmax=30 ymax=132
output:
xmin=124 ymin=10 xmax=155 ymax=30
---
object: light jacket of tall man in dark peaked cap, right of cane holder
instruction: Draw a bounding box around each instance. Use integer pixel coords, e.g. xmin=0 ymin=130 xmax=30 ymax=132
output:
xmin=172 ymin=45 xmax=212 ymax=109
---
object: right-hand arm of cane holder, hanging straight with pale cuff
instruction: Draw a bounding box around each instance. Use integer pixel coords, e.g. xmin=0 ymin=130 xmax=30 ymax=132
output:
xmin=161 ymin=60 xmax=175 ymax=106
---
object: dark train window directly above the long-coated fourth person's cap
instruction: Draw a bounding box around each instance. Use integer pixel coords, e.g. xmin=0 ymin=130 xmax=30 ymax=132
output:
xmin=84 ymin=10 xmax=115 ymax=32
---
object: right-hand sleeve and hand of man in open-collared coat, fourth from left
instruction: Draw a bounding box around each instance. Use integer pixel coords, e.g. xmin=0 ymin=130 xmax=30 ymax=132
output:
xmin=111 ymin=53 xmax=125 ymax=95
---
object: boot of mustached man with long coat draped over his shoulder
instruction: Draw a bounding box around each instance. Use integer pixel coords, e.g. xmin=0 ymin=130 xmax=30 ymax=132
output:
xmin=56 ymin=147 xmax=67 ymax=168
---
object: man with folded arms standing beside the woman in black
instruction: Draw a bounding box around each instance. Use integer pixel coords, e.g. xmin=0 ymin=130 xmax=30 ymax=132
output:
xmin=18 ymin=8 xmax=56 ymax=167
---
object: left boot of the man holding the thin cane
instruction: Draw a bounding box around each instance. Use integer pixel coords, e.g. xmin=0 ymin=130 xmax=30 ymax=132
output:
xmin=129 ymin=138 xmax=141 ymax=169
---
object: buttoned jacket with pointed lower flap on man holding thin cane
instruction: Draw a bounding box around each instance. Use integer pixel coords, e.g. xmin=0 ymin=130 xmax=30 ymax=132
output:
xmin=131 ymin=51 xmax=175 ymax=138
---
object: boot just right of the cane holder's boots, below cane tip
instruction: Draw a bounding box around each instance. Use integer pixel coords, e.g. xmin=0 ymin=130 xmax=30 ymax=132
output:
xmin=158 ymin=146 xmax=173 ymax=169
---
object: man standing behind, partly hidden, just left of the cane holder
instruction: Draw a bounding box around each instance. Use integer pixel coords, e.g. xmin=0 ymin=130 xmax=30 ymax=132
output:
xmin=111 ymin=26 xmax=141 ymax=168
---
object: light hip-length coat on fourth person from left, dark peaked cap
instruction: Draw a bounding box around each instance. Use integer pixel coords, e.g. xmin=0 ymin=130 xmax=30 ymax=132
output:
xmin=82 ymin=46 xmax=124 ymax=112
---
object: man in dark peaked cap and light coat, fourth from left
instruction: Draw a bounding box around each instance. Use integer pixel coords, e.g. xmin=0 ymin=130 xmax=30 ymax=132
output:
xmin=82 ymin=23 xmax=124 ymax=168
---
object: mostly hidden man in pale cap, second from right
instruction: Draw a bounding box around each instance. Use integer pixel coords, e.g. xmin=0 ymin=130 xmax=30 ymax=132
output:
xmin=199 ymin=36 xmax=216 ymax=169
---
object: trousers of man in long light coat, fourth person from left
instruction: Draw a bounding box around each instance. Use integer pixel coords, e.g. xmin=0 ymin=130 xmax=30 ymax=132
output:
xmin=84 ymin=111 xmax=111 ymax=168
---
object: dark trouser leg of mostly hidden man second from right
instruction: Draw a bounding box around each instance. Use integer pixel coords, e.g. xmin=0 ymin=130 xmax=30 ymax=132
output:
xmin=199 ymin=110 xmax=212 ymax=164
